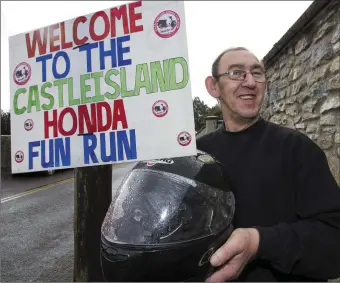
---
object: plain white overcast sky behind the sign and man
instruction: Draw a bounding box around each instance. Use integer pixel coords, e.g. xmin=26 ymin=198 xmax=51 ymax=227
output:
xmin=1 ymin=1 xmax=313 ymax=111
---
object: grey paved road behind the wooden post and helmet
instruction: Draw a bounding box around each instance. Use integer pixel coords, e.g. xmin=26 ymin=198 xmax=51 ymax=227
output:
xmin=1 ymin=163 xmax=135 ymax=282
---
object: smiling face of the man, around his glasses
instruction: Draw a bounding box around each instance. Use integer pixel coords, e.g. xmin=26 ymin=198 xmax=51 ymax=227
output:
xmin=216 ymin=50 xmax=266 ymax=118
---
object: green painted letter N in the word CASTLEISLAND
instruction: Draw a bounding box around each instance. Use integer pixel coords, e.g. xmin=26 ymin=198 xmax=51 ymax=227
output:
xmin=150 ymin=59 xmax=170 ymax=93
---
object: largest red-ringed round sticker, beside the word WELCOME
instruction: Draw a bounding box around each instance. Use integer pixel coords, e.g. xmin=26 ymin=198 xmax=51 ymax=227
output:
xmin=153 ymin=10 xmax=181 ymax=38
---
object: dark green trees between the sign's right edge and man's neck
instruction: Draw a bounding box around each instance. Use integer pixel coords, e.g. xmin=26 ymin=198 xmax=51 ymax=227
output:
xmin=193 ymin=96 xmax=223 ymax=131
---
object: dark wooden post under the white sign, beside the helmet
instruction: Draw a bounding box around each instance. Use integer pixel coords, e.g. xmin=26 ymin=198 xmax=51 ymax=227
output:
xmin=73 ymin=165 xmax=112 ymax=282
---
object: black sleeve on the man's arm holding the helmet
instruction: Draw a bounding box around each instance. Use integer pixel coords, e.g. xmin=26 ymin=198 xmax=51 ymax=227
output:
xmin=256 ymin=137 xmax=340 ymax=280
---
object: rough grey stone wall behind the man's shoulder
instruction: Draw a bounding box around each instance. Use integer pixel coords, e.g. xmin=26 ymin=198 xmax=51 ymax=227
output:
xmin=262 ymin=0 xmax=340 ymax=185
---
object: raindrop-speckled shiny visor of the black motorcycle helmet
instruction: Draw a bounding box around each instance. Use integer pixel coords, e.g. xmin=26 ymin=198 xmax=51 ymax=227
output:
xmin=102 ymin=169 xmax=234 ymax=246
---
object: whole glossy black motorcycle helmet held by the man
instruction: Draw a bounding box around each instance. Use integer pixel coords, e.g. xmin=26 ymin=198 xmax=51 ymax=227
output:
xmin=100 ymin=151 xmax=235 ymax=282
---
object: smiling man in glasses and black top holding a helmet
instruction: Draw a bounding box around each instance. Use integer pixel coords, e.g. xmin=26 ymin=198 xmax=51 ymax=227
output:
xmin=197 ymin=48 xmax=340 ymax=282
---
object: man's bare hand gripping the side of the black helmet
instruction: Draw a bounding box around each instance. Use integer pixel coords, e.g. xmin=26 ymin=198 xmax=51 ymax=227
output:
xmin=207 ymin=228 xmax=260 ymax=282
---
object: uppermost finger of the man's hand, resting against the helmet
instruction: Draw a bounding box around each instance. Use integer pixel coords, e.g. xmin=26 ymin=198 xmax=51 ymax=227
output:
xmin=210 ymin=235 xmax=239 ymax=266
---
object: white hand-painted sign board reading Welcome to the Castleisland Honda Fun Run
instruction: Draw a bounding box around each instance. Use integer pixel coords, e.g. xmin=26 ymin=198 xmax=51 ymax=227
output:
xmin=9 ymin=1 xmax=196 ymax=173
